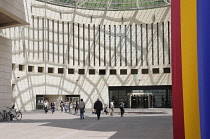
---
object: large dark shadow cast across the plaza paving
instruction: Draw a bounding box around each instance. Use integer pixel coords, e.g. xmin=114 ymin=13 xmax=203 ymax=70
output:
xmin=9 ymin=116 xmax=173 ymax=139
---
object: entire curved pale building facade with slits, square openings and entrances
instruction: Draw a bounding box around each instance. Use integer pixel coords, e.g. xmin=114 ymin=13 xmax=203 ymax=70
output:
xmin=1 ymin=0 xmax=172 ymax=110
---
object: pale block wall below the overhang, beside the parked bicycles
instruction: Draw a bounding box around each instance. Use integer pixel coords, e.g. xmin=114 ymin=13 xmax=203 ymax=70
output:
xmin=0 ymin=36 xmax=12 ymax=107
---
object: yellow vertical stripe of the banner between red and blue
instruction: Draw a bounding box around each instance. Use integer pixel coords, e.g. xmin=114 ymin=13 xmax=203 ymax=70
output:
xmin=180 ymin=0 xmax=200 ymax=139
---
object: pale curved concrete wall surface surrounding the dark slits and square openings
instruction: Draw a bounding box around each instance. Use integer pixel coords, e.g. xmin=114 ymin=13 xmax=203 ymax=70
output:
xmin=4 ymin=1 xmax=171 ymax=110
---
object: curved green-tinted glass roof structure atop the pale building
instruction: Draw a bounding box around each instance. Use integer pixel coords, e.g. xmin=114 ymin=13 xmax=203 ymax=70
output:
xmin=37 ymin=0 xmax=171 ymax=11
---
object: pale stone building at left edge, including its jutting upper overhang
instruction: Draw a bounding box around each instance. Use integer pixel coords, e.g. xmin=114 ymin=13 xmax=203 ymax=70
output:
xmin=0 ymin=0 xmax=30 ymax=108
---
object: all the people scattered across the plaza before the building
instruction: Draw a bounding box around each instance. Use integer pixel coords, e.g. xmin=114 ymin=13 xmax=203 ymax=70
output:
xmin=44 ymin=98 xmax=125 ymax=120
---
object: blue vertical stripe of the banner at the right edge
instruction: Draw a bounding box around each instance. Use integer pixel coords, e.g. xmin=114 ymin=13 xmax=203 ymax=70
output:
xmin=198 ymin=0 xmax=210 ymax=139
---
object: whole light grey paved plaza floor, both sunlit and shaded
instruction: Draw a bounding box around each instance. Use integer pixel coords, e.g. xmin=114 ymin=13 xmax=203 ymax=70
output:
xmin=0 ymin=108 xmax=173 ymax=139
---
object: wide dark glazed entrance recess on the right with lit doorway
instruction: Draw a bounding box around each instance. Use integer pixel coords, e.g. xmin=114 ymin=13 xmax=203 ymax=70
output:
xmin=109 ymin=85 xmax=172 ymax=108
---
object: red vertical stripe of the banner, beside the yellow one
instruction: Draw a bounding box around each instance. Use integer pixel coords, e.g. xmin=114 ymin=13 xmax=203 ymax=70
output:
xmin=171 ymin=0 xmax=185 ymax=139
